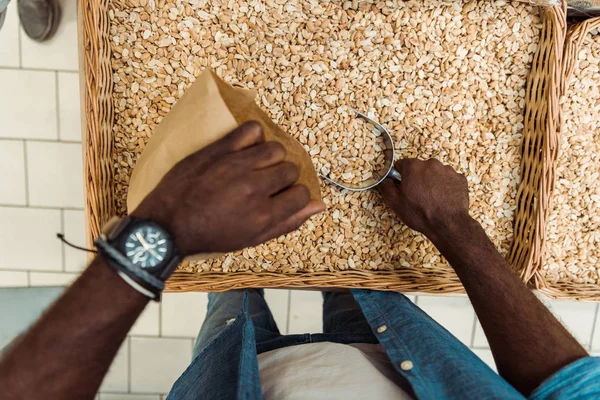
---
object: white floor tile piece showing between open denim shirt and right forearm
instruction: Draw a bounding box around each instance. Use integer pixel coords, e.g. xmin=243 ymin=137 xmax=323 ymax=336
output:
xmin=417 ymin=296 xmax=475 ymax=346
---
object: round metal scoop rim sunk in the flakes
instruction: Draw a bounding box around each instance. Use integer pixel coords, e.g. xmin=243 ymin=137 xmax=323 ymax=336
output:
xmin=321 ymin=108 xmax=402 ymax=191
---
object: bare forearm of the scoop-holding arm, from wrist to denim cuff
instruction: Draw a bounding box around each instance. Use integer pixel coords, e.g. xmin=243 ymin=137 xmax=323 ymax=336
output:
xmin=432 ymin=217 xmax=587 ymax=395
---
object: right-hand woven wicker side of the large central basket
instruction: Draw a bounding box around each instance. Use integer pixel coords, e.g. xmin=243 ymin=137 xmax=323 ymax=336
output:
xmin=511 ymin=6 xmax=567 ymax=282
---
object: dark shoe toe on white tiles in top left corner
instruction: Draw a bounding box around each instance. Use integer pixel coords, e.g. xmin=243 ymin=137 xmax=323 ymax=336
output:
xmin=17 ymin=0 xmax=61 ymax=42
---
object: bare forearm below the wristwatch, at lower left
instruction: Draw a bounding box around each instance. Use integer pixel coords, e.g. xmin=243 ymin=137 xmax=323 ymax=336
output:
xmin=0 ymin=257 xmax=149 ymax=399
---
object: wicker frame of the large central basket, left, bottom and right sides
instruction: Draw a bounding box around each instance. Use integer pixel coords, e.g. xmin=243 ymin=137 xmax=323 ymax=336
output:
xmin=79 ymin=0 xmax=566 ymax=293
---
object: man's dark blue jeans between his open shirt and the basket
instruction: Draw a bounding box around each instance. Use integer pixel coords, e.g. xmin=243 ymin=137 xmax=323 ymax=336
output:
xmin=193 ymin=289 xmax=378 ymax=358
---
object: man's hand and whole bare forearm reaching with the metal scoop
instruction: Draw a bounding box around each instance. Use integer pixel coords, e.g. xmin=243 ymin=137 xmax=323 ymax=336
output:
xmin=380 ymin=159 xmax=587 ymax=396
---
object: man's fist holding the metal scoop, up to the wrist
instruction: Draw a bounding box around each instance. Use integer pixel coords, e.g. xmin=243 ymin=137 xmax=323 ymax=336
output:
xmin=379 ymin=159 xmax=469 ymax=239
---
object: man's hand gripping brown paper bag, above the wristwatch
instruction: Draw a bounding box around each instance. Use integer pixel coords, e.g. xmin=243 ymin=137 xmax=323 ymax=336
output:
xmin=132 ymin=122 xmax=325 ymax=257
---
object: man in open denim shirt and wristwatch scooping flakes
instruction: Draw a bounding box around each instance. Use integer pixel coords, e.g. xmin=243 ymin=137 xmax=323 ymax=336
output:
xmin=0 ymin=123 xmax=600 ymax=399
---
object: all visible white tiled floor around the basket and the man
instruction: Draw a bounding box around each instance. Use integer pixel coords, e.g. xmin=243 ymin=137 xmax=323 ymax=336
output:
xmin=0 ymin=4 xmax=600 ymax=400
